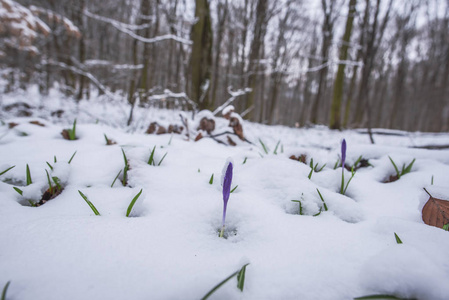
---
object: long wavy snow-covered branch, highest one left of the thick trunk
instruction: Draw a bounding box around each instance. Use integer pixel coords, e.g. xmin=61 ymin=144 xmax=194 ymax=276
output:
xmin=84 ymin=9 xmax=192 ymax=45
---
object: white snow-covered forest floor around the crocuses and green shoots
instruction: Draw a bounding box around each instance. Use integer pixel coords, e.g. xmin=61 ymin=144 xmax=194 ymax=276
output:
xmin=0 ymin=91 xmax=449 ymax=300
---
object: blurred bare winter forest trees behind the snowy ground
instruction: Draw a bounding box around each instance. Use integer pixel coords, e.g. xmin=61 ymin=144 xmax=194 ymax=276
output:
xmin=0 ymin=0 xmax=449 ymax=131
